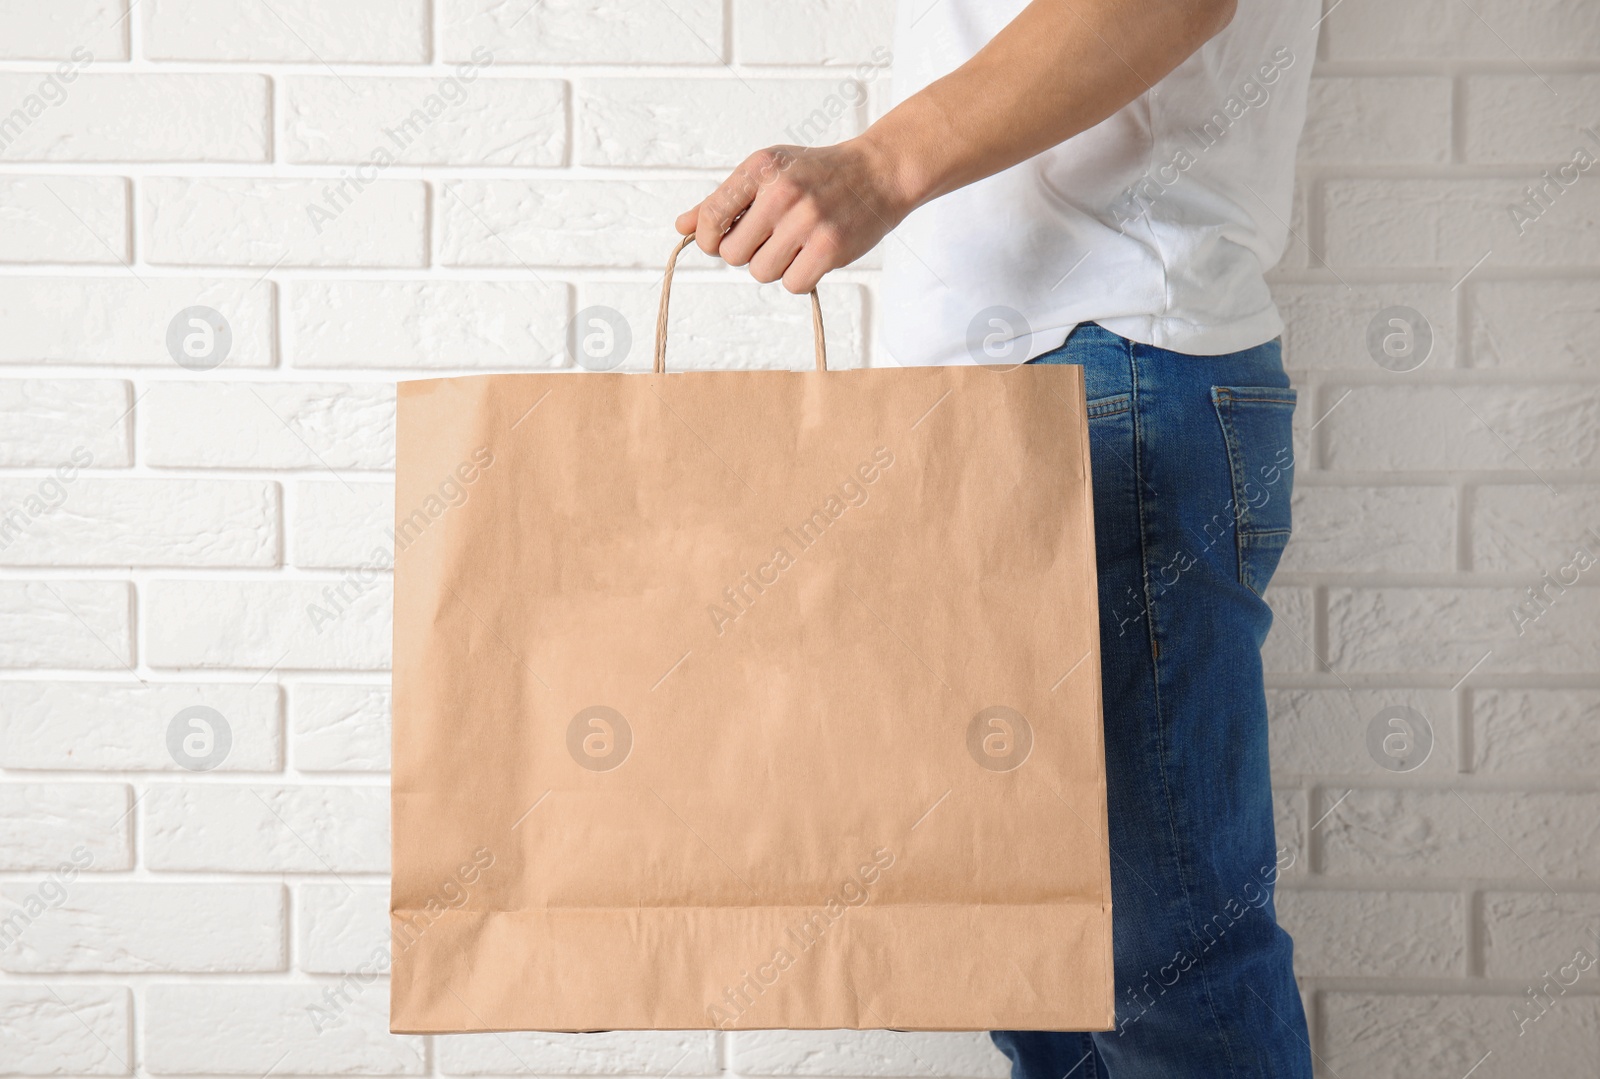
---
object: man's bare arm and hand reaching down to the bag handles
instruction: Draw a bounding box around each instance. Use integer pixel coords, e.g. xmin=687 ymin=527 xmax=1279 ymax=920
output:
xmin=677 ymin=0 xmax=1235 ymax=293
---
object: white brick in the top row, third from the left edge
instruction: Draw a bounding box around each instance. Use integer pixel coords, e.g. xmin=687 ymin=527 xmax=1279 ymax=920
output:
xmin=440 ymin=0 xmax=726 ymax=64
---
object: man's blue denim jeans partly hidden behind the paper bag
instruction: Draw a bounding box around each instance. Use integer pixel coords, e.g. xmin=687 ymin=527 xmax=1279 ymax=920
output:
xmin=992 ymin=323 xmax=1312 ymax=1079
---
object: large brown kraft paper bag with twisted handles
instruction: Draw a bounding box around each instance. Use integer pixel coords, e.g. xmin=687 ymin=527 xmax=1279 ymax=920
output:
xmin=390 ymin=236 xmax=1114 ymax=1034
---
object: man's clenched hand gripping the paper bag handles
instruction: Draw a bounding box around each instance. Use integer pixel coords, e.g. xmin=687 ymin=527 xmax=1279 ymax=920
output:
xmin=677 ymin=138 xmax=912 ymax=293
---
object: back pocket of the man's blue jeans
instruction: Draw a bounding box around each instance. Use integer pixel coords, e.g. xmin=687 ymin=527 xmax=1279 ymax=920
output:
xmin=1211 ymin=386 xmax=1296 ymax=596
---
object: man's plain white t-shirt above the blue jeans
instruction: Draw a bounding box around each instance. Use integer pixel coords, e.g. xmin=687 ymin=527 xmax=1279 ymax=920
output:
xmin=882 ymin=0 xmax=1322 ymax=367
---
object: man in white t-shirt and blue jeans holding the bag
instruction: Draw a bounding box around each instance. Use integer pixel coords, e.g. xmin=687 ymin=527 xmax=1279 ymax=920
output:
xmin=678 ymin=0 xmax=1320 ymax=1079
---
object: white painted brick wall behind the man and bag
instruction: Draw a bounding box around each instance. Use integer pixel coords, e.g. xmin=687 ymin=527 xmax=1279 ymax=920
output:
xmin=0 ymin=0 xmax=1600 ymax=1079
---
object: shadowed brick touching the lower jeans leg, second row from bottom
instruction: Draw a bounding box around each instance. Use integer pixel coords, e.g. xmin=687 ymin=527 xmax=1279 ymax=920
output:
xmin=1275 ymin=888 xmax=1467 ymax=978
